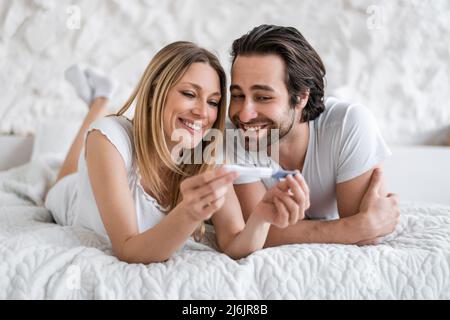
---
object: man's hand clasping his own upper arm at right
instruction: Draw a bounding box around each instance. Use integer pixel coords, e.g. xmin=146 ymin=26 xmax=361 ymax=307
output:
xmin=357 ymin=168 xmax=400 ymax=245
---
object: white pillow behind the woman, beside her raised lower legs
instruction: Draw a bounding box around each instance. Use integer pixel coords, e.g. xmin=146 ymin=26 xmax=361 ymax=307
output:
xmin=31 ymin=119 xmax=81 ymax=160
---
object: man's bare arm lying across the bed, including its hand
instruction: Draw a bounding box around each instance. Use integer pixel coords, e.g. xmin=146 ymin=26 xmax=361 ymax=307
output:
xmin=234 ymin=171 xmax=398 ymax=247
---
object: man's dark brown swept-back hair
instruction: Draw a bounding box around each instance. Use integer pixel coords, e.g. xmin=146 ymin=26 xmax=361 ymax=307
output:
xmin=231 ymin=25 xmax=326 ymax=121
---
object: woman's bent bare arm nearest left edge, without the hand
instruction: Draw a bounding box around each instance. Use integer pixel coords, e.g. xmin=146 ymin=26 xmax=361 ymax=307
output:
xmin=86 ymin=130 xmax=198 ymax=263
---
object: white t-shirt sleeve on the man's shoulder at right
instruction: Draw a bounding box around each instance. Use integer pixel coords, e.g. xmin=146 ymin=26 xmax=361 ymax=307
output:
xmin=336 ymin=104 xmax=391 ymax=183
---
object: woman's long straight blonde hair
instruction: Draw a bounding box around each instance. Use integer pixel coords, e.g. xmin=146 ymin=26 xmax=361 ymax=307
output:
xmin=117 ymin=41 xmax=226 ymax=241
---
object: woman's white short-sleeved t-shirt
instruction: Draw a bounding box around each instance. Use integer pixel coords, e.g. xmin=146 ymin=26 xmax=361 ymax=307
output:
xmin=46 ymin=116 xmax=165 ymax=239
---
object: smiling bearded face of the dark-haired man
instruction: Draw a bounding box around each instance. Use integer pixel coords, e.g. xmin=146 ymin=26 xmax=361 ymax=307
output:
xmin=229 ymin=54 xmax=298 ymax=149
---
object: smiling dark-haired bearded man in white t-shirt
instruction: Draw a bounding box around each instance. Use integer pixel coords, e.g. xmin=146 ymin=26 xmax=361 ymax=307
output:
xmin=229 ymin=25 xmax=399 ymax=247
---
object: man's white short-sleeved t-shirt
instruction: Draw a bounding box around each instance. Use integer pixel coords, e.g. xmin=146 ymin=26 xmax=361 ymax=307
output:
xmin=227 ymin=97 xmax=391 ymax=220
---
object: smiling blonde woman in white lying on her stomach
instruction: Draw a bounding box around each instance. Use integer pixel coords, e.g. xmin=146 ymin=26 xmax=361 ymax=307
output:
xmin=46 ymin=42 xmax=306 ymax=263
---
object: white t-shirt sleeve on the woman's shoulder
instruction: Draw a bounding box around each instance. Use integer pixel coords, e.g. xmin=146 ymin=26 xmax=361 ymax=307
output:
xmin=86 ymin=117 xmax=133 ymax=169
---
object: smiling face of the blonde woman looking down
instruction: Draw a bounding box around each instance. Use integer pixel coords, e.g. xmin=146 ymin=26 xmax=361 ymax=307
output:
xmin=163 ymin=62 xmax=221 ymax=150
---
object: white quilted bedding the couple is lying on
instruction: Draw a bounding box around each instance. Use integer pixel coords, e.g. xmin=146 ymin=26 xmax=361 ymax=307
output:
xmin=0 ymin=159 xmax=450 ymax=299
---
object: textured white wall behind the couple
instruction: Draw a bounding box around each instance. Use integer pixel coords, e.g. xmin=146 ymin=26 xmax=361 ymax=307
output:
xmin=0 ymin=0 xmax=450 ymax=144
